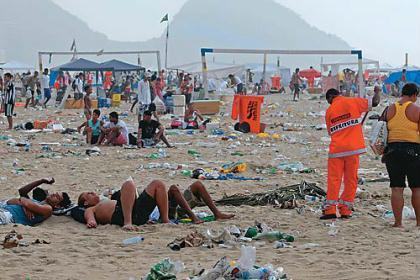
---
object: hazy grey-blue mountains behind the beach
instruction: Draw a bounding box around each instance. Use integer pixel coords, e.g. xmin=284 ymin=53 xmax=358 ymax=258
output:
xmin=0 ymin=0 xmax=350 ymax=68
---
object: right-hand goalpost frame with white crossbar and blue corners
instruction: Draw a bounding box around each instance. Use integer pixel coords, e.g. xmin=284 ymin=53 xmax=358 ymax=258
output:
xmin=201 ymin=48 xmax=365 ymax=97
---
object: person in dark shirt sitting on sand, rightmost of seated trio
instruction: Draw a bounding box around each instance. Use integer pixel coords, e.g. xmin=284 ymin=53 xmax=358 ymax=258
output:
xmin=137 ymin=111 xmax=172 ymax=148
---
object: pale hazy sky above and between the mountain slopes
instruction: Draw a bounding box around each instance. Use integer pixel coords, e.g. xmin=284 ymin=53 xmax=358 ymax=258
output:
xmin=53 ymin=0 xmax=420 ymax=66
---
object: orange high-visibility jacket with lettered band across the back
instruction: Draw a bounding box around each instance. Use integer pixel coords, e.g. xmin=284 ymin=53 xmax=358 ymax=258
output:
xmin=325 ymin=96 xmax=372 ymax=158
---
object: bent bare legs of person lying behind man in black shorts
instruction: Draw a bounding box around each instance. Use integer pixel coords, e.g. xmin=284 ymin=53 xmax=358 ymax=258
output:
xmin=168 ymin=181 xmax=235 ymax=224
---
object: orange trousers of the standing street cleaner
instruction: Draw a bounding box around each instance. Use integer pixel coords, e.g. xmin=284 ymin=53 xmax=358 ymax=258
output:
xmin=326 ymin=155 xmax=359 ymax=214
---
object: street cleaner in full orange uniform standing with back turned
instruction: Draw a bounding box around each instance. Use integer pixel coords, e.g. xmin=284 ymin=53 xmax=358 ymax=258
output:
xmin=321 ymin=89 xmax=380 ymax=220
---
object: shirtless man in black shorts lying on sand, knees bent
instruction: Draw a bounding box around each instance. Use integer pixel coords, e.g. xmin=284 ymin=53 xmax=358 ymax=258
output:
xmin=78 ymin=180 xmax=169 ymax=230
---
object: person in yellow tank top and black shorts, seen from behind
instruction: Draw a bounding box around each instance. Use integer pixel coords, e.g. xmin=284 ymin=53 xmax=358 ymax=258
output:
xmin=384 ymin=83 xmax=420 ymax=227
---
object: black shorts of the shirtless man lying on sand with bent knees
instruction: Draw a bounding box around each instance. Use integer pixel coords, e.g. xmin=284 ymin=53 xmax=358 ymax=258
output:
xmin=111 ymin=191 xmax=156 ymax=226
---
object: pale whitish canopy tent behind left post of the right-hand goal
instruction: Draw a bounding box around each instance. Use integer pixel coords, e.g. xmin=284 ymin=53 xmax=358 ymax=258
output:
xmin=168 ymin=62 xmax=245 ymax=80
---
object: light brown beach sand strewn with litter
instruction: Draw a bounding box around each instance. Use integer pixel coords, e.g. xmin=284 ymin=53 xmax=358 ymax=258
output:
xmin=0 ymin=95 xmax=420 ymax=279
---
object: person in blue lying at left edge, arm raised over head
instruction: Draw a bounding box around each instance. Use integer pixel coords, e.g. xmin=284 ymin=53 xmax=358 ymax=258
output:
xmin=0 ymin=178 xmax=71 ymax=226
